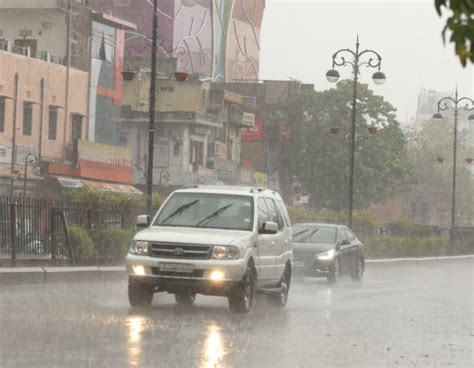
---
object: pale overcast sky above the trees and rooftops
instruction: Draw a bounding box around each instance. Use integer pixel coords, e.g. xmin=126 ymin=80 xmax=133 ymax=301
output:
xmin=260 ymin=0 xmax=474 ymax=123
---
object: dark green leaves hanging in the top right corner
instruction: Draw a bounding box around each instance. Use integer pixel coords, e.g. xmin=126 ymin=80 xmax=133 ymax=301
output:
xmin=435 ymin=0 xmax=474 ymax=66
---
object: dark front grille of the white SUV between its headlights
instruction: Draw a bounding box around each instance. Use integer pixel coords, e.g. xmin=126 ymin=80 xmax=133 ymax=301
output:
xmin=150 ymin=243 xmax=212 ymax=259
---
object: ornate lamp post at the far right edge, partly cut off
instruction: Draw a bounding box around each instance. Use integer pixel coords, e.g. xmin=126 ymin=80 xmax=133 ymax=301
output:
xmin=433 ymin=88 xmax=474 ymax=249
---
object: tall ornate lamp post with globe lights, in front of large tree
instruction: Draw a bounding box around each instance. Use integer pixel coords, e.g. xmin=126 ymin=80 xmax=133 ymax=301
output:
xmin=326 ymin=36 xmax=386 ymax=227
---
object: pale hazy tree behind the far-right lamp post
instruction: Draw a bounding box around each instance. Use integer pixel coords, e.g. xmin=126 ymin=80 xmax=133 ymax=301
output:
xmin=405 ymin=121 xmax=474 ymax=225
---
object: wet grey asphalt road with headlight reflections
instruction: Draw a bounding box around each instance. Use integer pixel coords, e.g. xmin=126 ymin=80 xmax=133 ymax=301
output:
xmin=0 ymin=259 xmax=474 ymax=368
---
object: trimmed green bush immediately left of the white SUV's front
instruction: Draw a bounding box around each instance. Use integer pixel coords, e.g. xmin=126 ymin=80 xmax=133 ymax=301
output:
xmin=89 ymin=229 xmax=135 ymax=261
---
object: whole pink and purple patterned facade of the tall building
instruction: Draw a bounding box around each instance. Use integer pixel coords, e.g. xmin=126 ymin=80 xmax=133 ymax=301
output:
xmin=90 ymin=0 xmax=265 ymax=82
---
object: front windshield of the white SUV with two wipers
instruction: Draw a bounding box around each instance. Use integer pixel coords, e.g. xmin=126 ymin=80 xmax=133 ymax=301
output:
xmin=153 ymin=193 xmax=253 ymax=230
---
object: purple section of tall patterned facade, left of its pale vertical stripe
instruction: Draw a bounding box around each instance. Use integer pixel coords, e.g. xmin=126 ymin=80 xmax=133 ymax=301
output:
xmin=91 ymin=0 xmax=212 ymax=77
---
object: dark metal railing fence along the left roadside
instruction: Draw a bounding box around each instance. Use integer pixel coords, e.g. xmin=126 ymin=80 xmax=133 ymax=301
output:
xmin=0 ymin=196 xmax=133 ymax=264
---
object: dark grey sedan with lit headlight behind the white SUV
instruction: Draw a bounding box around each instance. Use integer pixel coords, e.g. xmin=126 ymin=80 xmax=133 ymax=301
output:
xmin=293 ymin=223 xmax=365 ymax=283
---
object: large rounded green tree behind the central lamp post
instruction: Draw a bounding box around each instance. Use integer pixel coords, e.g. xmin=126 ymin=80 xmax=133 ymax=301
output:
xmin=270 ymin=81 xmax=410 ymax=210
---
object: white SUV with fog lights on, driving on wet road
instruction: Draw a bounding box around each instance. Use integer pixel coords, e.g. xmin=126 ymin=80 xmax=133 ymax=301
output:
xmin=127 ymin=186 xmax=293 ymax=313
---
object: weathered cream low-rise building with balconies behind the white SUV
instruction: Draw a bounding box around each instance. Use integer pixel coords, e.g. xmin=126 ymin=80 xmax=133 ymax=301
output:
xmin=120 ymin=73 xmax=255 ymax=186
